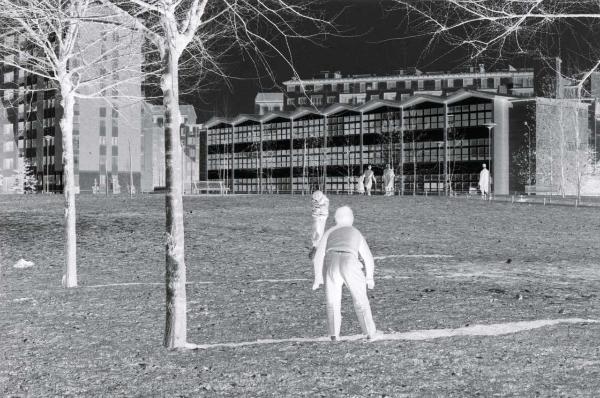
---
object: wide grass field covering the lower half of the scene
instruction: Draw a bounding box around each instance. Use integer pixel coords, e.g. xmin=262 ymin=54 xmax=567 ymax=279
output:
xmin=0 ymin=195 xmax=600 ymax=397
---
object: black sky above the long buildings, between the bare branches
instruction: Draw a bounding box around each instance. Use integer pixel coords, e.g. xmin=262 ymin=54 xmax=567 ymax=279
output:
xmin=183 ymin=0 xmax=596 ymax=122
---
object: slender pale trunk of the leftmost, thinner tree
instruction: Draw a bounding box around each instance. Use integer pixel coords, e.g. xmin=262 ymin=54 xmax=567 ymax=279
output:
xmin=60 ymin=83 xmax=77 ymax=287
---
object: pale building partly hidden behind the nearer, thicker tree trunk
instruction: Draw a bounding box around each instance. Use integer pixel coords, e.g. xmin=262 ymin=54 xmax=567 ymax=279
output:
xmin=141 ymin=102 xmax=199 ymax=192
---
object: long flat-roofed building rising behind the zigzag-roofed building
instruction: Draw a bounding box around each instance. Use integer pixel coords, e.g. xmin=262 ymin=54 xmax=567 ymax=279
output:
xmin=283 ymin=65 xmax=534 ymax=111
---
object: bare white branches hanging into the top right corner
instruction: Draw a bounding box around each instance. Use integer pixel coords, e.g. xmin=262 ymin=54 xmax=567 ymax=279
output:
xmin=393 ymin=0 xmax=600 ymax=84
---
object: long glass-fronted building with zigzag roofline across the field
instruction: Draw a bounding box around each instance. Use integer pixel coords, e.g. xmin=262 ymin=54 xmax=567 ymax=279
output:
xmin=200 ymin=90 xmax=531 ymax=194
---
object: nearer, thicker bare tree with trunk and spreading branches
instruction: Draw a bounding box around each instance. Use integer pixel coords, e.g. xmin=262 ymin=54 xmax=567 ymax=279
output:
xmin=104 ymin=0 xmax=323 ymax=348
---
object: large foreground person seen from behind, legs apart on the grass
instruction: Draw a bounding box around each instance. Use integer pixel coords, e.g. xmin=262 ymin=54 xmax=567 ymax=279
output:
xmin=313 ymin=206 xmax=377 ymax=341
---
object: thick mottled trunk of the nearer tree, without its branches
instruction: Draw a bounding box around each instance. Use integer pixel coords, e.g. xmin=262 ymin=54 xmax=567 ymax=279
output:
xmin=161 ymin=49 xmax=187 ymax=348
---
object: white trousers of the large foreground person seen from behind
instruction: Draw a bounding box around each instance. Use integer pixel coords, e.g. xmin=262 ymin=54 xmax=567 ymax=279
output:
xmin=323 ymin=252 xmax=375 ymax=337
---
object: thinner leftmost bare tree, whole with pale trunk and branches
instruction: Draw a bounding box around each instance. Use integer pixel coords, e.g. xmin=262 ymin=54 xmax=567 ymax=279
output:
xmin=0 ymin=0 xmax=139 ymax=287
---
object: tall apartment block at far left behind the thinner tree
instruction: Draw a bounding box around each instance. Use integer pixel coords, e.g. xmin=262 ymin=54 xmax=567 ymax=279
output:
xmin=0 ymin=13 xmax=142 ymax=192
